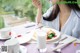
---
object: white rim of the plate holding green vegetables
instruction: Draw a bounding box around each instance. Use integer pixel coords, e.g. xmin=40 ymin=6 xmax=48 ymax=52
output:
xmin=32 ymin=27 xmax=61 ymax=41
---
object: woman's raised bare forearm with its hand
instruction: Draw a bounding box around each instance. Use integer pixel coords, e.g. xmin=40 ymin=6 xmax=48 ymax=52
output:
xmin=32 ymin=0 xmax=42 ymax=24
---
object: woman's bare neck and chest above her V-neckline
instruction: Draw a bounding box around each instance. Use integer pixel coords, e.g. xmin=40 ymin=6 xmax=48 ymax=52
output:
xmin=59 ymin=4 xmax=71 ymax=30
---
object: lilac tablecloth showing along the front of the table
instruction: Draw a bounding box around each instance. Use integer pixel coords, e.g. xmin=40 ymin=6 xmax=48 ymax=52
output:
xmin=0 ymin=22 xmax=80 ymax=53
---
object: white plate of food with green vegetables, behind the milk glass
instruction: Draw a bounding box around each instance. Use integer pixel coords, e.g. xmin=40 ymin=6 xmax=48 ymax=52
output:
xmin=32 ymin=27 xmax=61 ymax=41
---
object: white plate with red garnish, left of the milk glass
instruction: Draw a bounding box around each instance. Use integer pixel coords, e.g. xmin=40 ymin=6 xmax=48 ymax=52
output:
xmin=11 ymin=31 xmax=33 ymax=44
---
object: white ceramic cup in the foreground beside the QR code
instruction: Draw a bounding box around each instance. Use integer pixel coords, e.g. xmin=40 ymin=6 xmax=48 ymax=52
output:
xmin=4 ymin=38 xmax=20 ymax=53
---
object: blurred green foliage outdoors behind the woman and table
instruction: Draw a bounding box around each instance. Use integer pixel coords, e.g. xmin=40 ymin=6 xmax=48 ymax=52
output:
xmin=0 ymin=0 xmax=80 ymax=28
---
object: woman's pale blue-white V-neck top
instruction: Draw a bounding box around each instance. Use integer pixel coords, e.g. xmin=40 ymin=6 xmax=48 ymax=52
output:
xmin=42 ymin=7 xmax=80 ymax=38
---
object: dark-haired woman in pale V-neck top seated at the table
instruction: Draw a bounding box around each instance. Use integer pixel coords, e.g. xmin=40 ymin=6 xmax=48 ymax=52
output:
xmin=33 ymin=0 xmax=80 ymax=38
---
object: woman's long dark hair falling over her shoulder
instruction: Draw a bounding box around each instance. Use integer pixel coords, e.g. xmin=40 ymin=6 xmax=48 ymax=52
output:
xmin=43 ymin=0 xmax=80 ymax=21
